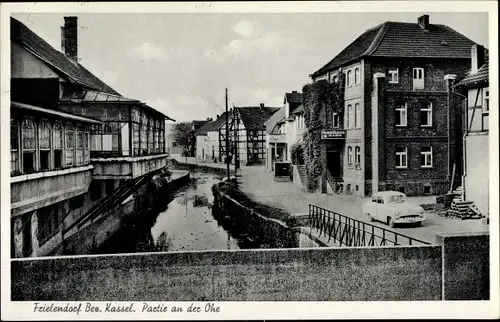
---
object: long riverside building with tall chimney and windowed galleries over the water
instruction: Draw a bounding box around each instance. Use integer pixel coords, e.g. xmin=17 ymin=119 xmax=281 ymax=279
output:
xmin=10 ymin=17 xmax=174 ymax=257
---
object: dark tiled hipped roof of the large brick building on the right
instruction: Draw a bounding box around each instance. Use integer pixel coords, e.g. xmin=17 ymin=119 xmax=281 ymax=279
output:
xmin=313 ymin=21 xmax=474 ymax=76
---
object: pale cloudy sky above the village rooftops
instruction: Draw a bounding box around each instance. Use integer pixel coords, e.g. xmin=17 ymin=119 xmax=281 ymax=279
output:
xmin=13 ymin=12 xmax=488 ymax=121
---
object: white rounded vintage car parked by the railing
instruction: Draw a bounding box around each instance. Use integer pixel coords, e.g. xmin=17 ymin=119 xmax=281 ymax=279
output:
xmin=363 ymin=191 xmax=425 ymax=228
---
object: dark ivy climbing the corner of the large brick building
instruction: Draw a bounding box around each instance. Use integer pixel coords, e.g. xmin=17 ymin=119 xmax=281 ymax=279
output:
xmin=302 ymin=73 xmax=345 ymax=191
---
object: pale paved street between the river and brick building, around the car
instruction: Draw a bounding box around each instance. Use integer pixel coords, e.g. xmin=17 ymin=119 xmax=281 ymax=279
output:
xmin=240 ymin=166 xmax=488 ymax=246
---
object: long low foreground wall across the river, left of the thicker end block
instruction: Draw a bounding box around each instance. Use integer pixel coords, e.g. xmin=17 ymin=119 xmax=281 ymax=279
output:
xmin=12 ymin=246 xmax=441 ymax=301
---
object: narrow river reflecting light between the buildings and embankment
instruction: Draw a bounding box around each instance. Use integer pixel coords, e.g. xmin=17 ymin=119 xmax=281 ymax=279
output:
xmin=94 ymin=172 xmax=249 ymax=254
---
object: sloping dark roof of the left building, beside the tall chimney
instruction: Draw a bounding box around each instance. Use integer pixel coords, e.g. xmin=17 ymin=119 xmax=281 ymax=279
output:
xmin=10 ymin=17 xmax=119 ymax=95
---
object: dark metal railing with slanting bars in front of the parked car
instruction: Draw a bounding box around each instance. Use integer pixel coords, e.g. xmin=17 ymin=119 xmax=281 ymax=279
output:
xmin=309 ymin=205 xmax=431 ymax=247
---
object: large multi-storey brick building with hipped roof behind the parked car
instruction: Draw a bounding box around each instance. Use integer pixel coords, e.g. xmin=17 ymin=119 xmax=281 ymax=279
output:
xmin=311 ymin=15 xmax=474 ymax=195
